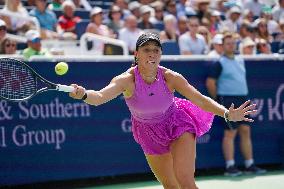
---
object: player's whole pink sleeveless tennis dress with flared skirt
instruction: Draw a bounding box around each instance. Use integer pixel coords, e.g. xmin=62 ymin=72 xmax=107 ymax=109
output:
xmin=125 ymin=66 xmax=214 ymax=155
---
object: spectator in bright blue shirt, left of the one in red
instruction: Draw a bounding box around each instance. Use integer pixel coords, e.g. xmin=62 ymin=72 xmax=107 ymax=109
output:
xmin=29 ymin=0 xmax=59 ymax=39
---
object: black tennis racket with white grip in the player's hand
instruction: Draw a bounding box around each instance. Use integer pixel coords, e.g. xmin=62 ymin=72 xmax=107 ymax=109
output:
xmin=0 ymin=58 xmax=74 ymax=102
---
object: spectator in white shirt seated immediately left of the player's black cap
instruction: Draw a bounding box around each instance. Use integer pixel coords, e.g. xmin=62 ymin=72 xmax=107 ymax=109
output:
xmin=118 ymin=15 xmax=143 ymax=54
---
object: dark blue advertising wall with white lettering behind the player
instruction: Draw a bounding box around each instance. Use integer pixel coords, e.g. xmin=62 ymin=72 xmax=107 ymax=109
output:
xmin=0 ymin=60 xmax=284 ymax=186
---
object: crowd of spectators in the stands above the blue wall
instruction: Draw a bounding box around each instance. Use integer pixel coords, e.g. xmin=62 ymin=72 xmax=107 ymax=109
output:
xmin=0 ymin=0 xmax=284 ymax=56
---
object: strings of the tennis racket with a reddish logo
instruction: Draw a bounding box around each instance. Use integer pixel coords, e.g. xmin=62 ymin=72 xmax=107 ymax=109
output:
xmin=0 ymin=60 xmax=36 ymax=99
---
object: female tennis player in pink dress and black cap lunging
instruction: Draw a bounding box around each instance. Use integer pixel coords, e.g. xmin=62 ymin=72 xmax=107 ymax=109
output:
xmin=70 ymin=33 xmax=256 ymax=189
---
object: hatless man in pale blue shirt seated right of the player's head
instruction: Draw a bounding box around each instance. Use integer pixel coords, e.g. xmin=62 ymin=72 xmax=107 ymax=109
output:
xmin=179 ymin=17 xmax=208 ymax=55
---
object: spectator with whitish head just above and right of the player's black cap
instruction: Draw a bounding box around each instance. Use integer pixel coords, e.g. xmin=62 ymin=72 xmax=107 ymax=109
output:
xmin=160 ymin=14 xmax=178 ymax=43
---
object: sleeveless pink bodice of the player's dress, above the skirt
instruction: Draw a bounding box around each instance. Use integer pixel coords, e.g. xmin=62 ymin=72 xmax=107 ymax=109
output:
xmin=125 ymin=66 xmax=174 ymax=122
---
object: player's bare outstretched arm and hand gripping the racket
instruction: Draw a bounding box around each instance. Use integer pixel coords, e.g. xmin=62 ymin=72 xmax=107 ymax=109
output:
xmin=70 ymin=72 xmax=133 ymax=106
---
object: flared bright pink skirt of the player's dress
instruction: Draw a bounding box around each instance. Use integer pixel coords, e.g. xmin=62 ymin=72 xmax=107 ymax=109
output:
xmin=132 ymin=98 xmax=214 ymax=155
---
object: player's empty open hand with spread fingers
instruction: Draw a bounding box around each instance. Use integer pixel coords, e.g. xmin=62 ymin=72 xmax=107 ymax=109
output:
xmin=229 ymin=100 xmax=257 ymax=122
